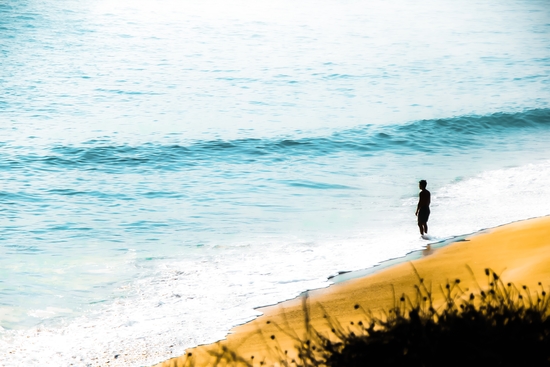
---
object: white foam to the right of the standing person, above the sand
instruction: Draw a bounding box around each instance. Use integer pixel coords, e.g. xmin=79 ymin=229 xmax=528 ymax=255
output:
xmin=431 ymin=161 xmax=550 ymax=235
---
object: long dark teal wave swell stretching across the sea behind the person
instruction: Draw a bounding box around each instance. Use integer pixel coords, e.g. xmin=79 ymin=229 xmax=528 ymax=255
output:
xmin=4 ymin=109 xmax=550 ymax=170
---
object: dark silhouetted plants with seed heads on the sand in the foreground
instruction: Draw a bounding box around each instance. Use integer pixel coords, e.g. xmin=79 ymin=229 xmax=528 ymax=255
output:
xmin=187 ymin=269 xmax=550 ymax=367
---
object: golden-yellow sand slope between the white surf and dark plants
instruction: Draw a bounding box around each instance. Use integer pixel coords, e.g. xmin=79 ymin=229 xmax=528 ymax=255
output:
xmin=156 ymin=217 xmax=550 ymax=367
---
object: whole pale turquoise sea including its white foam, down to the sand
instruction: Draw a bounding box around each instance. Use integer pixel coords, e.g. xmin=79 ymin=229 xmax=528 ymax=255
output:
xmin=0 ymin=0 xmax=550 ymax=367
